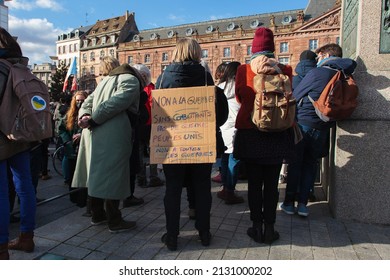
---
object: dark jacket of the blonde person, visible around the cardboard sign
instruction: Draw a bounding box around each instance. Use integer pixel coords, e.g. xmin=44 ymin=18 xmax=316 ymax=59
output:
xmin=156 ymin=61 xmax=229 ymax=157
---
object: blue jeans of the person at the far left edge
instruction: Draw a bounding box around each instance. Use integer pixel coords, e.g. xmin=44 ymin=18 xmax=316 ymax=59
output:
xmin=0 ymin=151 xmax=36 ymax=244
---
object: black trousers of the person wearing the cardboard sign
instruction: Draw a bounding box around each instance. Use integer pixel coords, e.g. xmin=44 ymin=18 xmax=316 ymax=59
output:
xmin=163 ymin=163 xmax=212 ymax=236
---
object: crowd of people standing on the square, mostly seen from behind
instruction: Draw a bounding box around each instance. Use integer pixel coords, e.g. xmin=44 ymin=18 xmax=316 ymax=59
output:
xmin=0 ymin=24 xmax=356 ymax=259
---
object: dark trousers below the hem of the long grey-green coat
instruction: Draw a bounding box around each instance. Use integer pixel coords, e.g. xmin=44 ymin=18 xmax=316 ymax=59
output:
xmin=90 ymin=196 xmax=122 ymax=226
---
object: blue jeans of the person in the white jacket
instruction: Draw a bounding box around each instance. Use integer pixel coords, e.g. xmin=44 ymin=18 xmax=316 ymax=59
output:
xmin=221 ymin=153 xmax=240 ymax=192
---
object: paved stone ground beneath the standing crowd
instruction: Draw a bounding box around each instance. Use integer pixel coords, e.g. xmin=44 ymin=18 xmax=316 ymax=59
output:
xmin=10 ymin=161 xmax=390 ymax=260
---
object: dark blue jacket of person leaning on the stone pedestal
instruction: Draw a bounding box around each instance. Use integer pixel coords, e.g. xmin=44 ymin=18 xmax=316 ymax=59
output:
xmin=293 ymin=57 xmax=356 ymax=130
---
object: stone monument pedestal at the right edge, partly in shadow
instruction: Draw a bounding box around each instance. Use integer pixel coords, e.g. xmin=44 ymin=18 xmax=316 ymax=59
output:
xmin=324 ymin=0 xmax=390 ymax=224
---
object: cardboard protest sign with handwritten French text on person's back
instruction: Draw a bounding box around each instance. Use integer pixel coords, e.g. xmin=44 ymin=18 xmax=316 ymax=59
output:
xmin=150 ymin=86 xmax=216 ymax=164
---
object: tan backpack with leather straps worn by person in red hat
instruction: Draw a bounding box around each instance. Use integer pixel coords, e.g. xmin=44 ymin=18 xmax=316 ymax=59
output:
xmin=252 ymin=67 xmax=296 ymax=132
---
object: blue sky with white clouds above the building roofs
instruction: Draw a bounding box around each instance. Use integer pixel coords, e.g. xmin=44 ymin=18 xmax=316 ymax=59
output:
xmin=4 ymin=0 xmax=310 ymax=65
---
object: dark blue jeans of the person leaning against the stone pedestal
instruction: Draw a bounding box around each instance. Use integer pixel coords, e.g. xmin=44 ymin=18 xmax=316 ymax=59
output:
xmin=284 ymin=124 xmax=329 ymax=205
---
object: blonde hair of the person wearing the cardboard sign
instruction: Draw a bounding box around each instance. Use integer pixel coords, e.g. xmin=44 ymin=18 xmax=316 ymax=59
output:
xmin=173 ymin=38 xmax=202 ymax=62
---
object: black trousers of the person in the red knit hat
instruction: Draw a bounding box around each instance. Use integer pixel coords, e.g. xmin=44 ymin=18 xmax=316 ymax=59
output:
xmin=245 ymin=162 xmax=282 ymax=224
